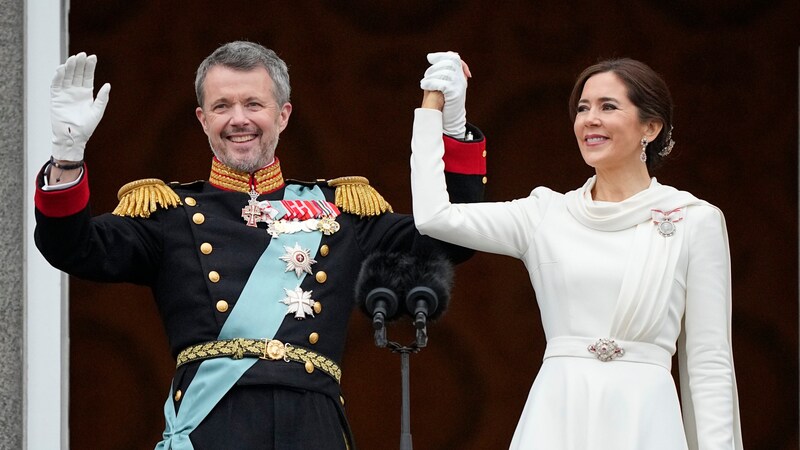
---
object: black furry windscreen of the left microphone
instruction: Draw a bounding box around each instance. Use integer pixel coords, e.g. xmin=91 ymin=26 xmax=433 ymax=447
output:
xmin=355 ymin=253 xmax=410 ymax=320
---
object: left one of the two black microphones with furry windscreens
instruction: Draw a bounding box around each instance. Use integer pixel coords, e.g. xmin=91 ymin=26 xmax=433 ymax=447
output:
xmin=355 ymin=253 xmax=410 ymax=347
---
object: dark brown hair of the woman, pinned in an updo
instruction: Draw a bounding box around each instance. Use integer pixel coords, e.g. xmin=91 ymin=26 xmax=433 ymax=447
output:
xmin=569 ymin=58 xmax=674 ymax=170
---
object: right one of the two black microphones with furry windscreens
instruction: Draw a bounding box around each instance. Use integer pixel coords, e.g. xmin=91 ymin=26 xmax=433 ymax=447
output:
xmin=405 ymin=253 xmax=453 ymax=347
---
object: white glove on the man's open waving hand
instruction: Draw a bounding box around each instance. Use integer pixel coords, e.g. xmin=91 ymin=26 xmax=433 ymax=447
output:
xmin=50 ymin=52 xmax=111 ymax=161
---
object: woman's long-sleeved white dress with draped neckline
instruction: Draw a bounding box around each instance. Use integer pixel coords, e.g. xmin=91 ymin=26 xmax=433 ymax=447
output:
xmin=411 ymin=109 xmax=742 ymax=450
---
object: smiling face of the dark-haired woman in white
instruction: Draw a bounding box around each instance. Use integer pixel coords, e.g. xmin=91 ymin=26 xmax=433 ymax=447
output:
xmin=573 ymin=72 xmax=658 ymax=170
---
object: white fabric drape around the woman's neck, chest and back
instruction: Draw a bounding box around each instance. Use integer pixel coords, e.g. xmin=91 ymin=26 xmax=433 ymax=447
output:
xmin=565 ymin=177 xmax=743 ymax=450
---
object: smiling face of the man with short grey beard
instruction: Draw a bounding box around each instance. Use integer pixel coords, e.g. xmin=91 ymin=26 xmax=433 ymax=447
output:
xmin=195 ymin=65 xmax=292 ymax=172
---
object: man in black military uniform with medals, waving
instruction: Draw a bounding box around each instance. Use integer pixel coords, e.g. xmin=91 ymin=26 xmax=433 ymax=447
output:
xmin=35 ymin=41 xmax=485 ymax=450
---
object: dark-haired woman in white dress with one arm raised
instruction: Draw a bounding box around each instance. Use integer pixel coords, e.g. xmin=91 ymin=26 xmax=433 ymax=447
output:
xmin=411 ymin=53 xmax=742 ymax=450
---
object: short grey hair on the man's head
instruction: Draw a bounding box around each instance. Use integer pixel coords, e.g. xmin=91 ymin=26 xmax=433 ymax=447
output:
xmin=194 ymin=41 xmax=292 ymax=108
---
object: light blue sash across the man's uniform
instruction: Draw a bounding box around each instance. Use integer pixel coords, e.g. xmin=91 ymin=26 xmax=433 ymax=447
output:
xmin=156 ymin=185 xmax=325 ymax=450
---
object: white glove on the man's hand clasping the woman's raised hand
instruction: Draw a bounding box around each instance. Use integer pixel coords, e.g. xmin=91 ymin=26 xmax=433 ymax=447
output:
xmin=419 ymin=52 xmax=469 ymax=138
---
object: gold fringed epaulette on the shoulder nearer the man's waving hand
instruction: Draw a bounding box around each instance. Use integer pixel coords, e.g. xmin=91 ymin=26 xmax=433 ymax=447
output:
xmin=112 ymin=178 xmax=181 ymax=218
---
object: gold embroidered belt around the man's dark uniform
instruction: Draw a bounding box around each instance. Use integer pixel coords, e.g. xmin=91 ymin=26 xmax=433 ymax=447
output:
xmin=175 ymin=338 xmax=342 ymax=383
